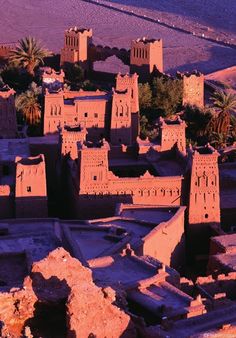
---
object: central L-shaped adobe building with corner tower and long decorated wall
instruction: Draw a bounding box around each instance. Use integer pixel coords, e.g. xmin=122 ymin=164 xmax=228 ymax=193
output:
xmin=68 ymin=140 xmax=183 ymax=218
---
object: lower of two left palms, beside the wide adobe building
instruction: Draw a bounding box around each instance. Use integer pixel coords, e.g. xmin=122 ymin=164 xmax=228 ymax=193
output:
xmin=16 ymin=82 xmax=41 ymax=125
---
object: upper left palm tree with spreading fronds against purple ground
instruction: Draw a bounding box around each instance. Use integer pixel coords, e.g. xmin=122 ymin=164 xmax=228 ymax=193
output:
xmin=9 ymin=37 xmax=51 ymax=76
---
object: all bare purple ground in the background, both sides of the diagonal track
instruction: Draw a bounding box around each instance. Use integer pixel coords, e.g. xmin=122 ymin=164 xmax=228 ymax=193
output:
xmin=0 ymin=0 xmax=236 ymax=74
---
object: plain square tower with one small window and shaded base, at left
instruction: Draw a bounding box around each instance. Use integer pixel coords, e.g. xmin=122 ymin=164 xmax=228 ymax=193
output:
xmin=15 ymin=154 xmax=48 ymax=218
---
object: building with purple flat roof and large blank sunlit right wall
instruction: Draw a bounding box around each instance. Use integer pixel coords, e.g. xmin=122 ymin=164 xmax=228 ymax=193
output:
xmin=62 ymin=203 xmax=185 ymax=271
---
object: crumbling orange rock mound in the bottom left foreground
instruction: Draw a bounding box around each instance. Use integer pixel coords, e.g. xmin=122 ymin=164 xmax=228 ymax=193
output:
xmin=0 ymin=248 xmax=136 ymax=338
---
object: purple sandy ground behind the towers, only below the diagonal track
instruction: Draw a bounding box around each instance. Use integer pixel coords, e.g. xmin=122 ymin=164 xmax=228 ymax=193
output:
xmin=0 ymin=0 xmax=236 ymax=73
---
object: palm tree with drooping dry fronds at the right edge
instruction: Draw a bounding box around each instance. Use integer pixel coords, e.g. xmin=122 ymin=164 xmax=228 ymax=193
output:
xmin=209 ymin=90 xmax=236 ymax=135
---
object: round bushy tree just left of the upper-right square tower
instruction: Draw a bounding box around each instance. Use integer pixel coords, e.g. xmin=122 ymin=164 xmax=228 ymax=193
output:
xmin=152 ymin=77 xmax=183 ymax=117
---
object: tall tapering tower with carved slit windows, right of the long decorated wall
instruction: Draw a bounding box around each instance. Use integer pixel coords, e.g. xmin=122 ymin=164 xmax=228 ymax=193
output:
xmin=189 ymin=145 xmax=220 ymax=225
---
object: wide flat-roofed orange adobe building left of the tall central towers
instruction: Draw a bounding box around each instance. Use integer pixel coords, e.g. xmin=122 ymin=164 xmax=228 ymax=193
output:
xmin=44 ymin=89 xmax=111 ymax=140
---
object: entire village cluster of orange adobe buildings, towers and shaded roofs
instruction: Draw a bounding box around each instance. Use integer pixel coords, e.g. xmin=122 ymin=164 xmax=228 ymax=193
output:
xmin=0 ymin=27 xmax=236 ymax=338
